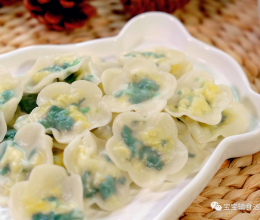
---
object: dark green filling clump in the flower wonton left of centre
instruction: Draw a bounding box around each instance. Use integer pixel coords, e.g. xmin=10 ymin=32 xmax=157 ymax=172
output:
xmin=39 ymin=105 xmax=75 ymax=131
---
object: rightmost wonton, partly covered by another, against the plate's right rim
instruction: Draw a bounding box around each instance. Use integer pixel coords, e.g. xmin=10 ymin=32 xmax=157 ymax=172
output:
xmin=184 ymin=101 xmax=250 ymax=143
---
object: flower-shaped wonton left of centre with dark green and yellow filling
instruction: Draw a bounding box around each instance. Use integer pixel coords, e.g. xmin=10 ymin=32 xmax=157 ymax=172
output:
xmin=18 ymin=80 xmax=112 ymax=143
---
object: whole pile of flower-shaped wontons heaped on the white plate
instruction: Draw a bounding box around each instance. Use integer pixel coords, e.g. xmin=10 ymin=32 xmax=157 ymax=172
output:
xmin=0 ymin=47 xmax=249 ymax=220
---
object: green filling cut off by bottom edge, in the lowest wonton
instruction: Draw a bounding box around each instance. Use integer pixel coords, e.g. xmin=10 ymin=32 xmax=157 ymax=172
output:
xmin=32 ymin=211 xmax=85 ymax=220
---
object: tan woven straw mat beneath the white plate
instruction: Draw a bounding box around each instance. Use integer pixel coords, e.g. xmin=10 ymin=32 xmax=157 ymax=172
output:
xmin=0 ymin=0 xmax=260 ymax=220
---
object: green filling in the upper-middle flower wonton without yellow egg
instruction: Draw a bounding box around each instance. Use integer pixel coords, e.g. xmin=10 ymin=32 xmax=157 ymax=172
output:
xmin=114 ymin=78 xmax=160 ymax=104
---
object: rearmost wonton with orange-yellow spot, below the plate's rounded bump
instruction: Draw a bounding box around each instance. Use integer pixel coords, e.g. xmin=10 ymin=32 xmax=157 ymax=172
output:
xmin=118 ymin=47 xmax=193 ymax=79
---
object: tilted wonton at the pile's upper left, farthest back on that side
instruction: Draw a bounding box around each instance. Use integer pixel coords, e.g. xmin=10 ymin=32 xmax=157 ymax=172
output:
xmin=24 ymin=54 xmax=86 ymax=93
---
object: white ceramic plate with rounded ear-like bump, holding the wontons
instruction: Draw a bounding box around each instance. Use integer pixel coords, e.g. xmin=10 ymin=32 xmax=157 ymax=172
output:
xmin=0 ymin=12 xmax=260 ymax=220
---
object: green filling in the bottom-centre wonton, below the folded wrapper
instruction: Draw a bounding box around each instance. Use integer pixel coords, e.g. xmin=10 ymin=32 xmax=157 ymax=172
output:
xmin=81 ymin=171 xmax=120 ymax=201
